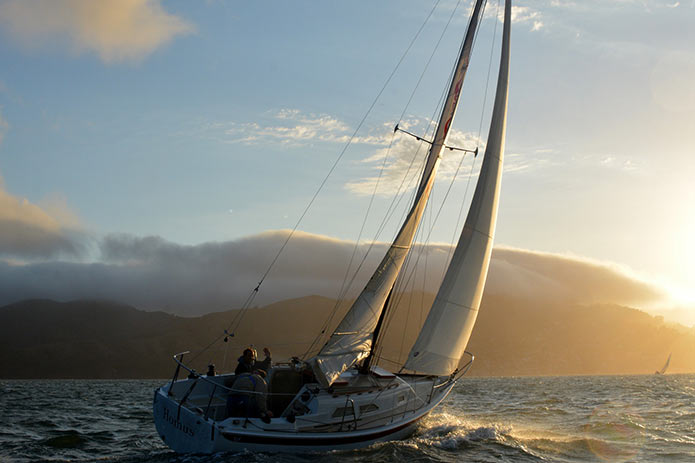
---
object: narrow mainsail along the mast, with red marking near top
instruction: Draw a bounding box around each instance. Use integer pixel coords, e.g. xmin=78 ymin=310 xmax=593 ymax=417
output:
xmin=309 ymin=0 xmax=484 ymax=387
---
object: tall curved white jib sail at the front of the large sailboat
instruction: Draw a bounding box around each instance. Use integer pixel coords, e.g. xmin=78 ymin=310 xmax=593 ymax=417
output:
xmin=404 ymin=0 xmax=511 ymax=375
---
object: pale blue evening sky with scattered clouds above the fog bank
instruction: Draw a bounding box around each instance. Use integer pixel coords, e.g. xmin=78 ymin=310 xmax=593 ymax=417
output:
xmin=0 ymin=0 xmax=695 ymax=324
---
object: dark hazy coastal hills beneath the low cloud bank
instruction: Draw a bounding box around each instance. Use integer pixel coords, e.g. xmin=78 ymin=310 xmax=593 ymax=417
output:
xmin=0 ymin=294 xmax=695 ymax=378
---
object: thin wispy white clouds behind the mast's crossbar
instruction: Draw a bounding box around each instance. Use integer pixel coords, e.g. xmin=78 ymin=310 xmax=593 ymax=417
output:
xmin=209 ymin=109 xmax=540 ymax=196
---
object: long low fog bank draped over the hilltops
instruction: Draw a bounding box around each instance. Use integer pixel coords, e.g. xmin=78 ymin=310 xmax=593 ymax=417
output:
xmin=0 ymin=231 xmax=666 ymax=324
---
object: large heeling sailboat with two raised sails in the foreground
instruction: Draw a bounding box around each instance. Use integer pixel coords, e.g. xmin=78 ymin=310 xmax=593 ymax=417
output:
xmin=153 ymin=0 xmax=511 ymax=453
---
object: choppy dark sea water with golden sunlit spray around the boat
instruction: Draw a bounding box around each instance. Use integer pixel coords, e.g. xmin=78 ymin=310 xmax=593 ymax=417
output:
xmin=0 ymin=375 xmax=695 ymax=463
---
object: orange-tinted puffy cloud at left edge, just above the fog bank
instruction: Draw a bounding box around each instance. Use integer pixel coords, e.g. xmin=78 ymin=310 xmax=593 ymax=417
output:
xmin=0 ymin=178 xmax=84 ymax=260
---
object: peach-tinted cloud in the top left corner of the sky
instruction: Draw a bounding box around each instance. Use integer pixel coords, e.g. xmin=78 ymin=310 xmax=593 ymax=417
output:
xmin=0 ymin=0 xmax=193 ymax=63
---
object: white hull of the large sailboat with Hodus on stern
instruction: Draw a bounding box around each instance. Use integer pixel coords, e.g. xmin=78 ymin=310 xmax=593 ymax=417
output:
xmin=154 ymin=378 xmax=454 ymax=454
